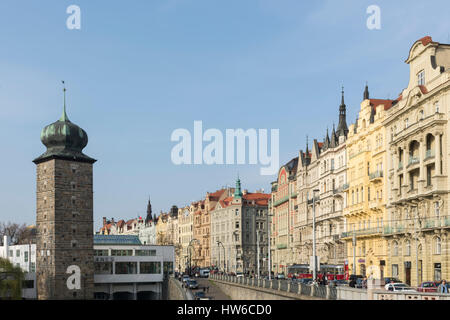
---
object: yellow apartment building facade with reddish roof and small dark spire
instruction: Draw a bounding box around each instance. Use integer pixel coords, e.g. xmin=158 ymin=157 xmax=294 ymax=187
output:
xmin=342 ymin=86 xmax=392 ymax=279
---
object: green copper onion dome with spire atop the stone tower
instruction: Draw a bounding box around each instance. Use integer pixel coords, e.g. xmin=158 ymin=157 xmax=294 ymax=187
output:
xmin=33 ymin=89 xmax=96 ymax=163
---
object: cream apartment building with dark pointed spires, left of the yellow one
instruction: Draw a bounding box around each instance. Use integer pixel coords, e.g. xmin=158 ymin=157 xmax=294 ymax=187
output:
xmin=294 ymin=92 xmax=348 ymax=271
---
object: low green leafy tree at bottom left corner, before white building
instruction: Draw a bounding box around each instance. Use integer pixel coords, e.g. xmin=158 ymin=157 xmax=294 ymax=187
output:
xmin=0 ymin=258 xmax=24 ymax=300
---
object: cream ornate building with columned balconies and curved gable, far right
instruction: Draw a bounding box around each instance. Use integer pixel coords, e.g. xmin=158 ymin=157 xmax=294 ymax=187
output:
xmin=384 ymin=37 xmax=450 ymax=286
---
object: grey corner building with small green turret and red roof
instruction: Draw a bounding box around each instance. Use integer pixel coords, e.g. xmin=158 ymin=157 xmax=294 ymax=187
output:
xmin=210 ymin=179 xmax=270 ymax=274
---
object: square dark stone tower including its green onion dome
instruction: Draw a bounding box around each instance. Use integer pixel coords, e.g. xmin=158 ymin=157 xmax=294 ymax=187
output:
xmin=33 ymin=89 xmax=96 ymax=300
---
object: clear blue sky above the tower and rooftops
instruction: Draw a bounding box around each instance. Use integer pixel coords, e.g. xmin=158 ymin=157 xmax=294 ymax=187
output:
xmin=0 ymin=0 xmax=450 ymax=227
